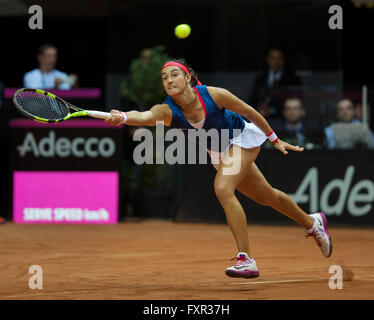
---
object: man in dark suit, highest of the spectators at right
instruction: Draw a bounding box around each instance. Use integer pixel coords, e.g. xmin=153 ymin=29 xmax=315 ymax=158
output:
xmin=249 ymin=48 xmax=301 ymax=119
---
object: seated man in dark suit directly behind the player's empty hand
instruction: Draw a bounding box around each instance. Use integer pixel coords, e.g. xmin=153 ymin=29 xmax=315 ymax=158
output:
xmin=269 ymin=97 xmax=323 ymax=149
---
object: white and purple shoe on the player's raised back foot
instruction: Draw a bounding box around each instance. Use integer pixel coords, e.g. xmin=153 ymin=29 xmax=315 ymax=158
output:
xmin=305 ymin=212 xmax=332 ymax=258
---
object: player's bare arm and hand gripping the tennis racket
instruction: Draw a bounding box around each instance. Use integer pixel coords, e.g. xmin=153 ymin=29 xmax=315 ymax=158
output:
xmin=105 ymin=104 xmax=172 ymax=126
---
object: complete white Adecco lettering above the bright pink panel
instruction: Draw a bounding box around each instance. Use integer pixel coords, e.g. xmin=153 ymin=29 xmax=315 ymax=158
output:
xmin=17 ymin=130 xmax=116 ymax=158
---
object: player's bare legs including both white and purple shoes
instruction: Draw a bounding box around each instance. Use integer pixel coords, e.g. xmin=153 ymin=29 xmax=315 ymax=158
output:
xmin=214 ymin=145 xmax=332 ymax=278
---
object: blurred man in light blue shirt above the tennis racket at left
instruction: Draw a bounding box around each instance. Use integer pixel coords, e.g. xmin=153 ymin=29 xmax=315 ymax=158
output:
xmin=23 ymin=44 xmax=78 ymax=90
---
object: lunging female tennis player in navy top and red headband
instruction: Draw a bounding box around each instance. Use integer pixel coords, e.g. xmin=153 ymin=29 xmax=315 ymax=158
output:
xmin=106 ymin=59 xmax=332 ymax=278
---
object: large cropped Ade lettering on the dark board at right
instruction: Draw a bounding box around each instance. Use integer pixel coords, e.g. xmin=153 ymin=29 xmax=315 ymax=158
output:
xmin=290 ymin=166 xmax=374 ymax=217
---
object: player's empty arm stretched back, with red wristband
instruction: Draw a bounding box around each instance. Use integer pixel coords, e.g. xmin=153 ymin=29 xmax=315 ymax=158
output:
xmin=208 ymin=87 xmax=304 ymax=154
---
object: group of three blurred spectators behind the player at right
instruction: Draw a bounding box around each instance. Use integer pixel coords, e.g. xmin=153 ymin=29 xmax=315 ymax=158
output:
xmin=248 ymin=48 xmax=374 ymax=149
